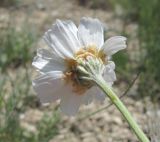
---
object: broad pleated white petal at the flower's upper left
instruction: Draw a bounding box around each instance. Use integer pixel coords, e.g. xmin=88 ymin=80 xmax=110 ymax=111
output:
xmin=44 ymin=20 xmax=81 ymax=58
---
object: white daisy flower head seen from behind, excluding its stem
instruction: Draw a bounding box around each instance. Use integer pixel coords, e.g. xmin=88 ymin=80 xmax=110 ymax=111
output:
xmin=32 ymin=17 xmax=126 ymax=115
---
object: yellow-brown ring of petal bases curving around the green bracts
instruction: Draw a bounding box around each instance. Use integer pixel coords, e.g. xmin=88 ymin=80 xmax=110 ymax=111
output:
xmin=64 ymin=45 xmax=106 ymax=95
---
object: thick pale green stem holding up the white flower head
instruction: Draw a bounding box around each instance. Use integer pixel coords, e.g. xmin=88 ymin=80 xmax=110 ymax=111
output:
xmin=95 ymin=76 xmax=149 ymax=142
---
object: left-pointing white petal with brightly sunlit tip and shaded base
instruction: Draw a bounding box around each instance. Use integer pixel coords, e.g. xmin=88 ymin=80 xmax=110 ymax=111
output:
xmin=32 ymin=56 xmax=66 ymax=73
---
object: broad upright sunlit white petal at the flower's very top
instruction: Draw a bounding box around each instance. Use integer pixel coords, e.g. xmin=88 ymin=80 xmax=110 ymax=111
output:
xmin=78 ymin=17 xmax=104 ymax=49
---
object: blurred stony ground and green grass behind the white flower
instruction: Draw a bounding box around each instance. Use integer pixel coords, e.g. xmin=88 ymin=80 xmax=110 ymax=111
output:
xmin=0 ymin=0 xmax=160 ymax=142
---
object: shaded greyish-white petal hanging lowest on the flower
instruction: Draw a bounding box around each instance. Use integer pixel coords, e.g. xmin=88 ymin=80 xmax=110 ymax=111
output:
xmin=60 ymin=85 xmax=83 ymax=116
